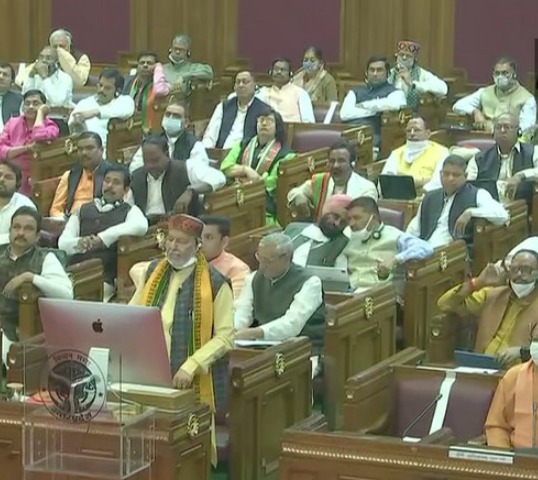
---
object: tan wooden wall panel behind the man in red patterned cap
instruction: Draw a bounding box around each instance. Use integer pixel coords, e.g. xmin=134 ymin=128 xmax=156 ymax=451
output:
xmin=340 ymin=0 xmax=455 ymax=79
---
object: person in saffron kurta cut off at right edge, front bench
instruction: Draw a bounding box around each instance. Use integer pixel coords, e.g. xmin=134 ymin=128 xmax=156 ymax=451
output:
xmin=485 ymin=344 xmax=538 ymax=449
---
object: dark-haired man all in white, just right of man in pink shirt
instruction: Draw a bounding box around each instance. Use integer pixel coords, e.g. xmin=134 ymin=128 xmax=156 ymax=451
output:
xmin=68 ymin=68 xmax=135 ymax=151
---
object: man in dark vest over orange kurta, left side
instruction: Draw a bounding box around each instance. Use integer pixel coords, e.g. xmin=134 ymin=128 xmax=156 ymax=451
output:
xmin=49 ymin=132 xmax=111 ymax=219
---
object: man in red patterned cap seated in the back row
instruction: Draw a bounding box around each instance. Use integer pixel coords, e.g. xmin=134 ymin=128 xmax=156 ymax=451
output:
xmin=389 ymin=40 xmax=448 ymax=111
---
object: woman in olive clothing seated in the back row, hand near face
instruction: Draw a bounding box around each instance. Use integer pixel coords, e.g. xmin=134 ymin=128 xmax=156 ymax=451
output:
xmin=292 ymin=47 xmax=338 ymax=102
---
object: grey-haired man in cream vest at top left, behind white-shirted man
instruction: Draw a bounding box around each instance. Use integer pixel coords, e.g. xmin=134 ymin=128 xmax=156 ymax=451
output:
xmin=15 ymin=28 xmax=91 ymax=88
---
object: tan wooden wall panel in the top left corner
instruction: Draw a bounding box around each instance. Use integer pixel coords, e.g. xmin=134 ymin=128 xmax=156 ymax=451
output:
xmin=0 ymin=0 xmax=51 ymax=62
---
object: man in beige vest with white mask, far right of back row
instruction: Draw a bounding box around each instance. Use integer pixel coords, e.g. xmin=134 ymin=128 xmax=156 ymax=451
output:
xmin=452 ymin=57 xmax=536 ymax=132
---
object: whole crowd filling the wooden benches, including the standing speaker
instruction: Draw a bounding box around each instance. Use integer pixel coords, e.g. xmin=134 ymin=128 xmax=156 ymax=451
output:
xmin=0 ymin=26 xmax=538 ymax=472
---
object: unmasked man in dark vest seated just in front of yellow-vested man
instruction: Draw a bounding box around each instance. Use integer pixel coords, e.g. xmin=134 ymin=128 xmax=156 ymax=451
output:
xmin=407 ymin=155 xmax=510 ymax=248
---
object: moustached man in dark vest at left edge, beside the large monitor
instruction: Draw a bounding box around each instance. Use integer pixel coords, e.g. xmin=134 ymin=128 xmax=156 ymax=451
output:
xmin=0 ymin=207 xmax=73 ymax=362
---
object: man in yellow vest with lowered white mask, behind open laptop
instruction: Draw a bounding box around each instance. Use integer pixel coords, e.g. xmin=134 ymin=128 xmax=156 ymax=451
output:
xmin=381 ymin=118 xmax=448 ymax=192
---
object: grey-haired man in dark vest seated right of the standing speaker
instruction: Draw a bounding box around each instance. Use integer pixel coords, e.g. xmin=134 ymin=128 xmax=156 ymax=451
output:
xmin=234 ymin=233 xmax=325 ymax=355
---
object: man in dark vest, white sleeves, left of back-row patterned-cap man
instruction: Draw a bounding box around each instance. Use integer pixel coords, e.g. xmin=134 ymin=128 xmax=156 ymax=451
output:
xmin=340 ymin=55 xmax=407 ymax=152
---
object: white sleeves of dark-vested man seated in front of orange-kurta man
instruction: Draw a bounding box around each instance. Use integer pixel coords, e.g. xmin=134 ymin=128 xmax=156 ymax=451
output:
xmin=58 ymin=205 xmax=148 ymax=255
